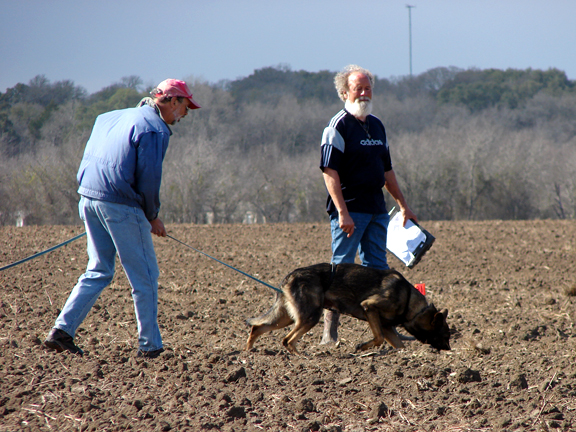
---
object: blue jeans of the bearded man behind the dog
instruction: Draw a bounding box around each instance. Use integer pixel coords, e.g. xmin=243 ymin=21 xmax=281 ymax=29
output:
xmin=330 ymin=212 xmax=390 ymax=270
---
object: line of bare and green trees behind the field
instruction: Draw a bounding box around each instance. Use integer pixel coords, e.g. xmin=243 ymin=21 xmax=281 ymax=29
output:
xmin=0 ymin=65 xmax=576 ymax=225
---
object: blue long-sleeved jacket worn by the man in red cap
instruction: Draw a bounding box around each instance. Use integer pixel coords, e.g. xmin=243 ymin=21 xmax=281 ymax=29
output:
xmin=77 ymin=105 xmax=172 ymax=221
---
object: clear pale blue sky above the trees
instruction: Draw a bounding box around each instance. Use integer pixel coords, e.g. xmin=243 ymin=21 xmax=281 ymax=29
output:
xmin=0 ymin=0 xmax=576 ymax=93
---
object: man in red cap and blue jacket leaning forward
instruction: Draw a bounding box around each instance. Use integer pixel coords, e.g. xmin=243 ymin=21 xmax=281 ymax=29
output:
xmin=44 ymin=79 xmax=200 ymax=358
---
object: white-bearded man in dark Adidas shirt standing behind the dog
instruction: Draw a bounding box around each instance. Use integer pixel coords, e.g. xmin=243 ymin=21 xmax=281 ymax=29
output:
xmin=320 ymin=65 xmax=417 ymax=343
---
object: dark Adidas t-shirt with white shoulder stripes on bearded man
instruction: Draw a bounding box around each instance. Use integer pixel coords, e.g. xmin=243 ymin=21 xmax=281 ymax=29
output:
xmin=320 ymin=109 xmax=392 ymax=214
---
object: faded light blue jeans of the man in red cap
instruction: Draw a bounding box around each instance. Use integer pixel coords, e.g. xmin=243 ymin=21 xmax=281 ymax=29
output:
xmin=54 ymin=197 xmax=162 ymax=351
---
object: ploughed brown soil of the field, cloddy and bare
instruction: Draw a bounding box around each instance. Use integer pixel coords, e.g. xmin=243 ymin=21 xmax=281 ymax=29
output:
xmin=0 ymin=221 xmax=576 ymax=432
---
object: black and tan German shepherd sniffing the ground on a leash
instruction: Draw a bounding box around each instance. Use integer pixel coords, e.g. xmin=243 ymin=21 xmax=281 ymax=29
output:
xmin=246 ymin=263 xmax=450 ymax=354
